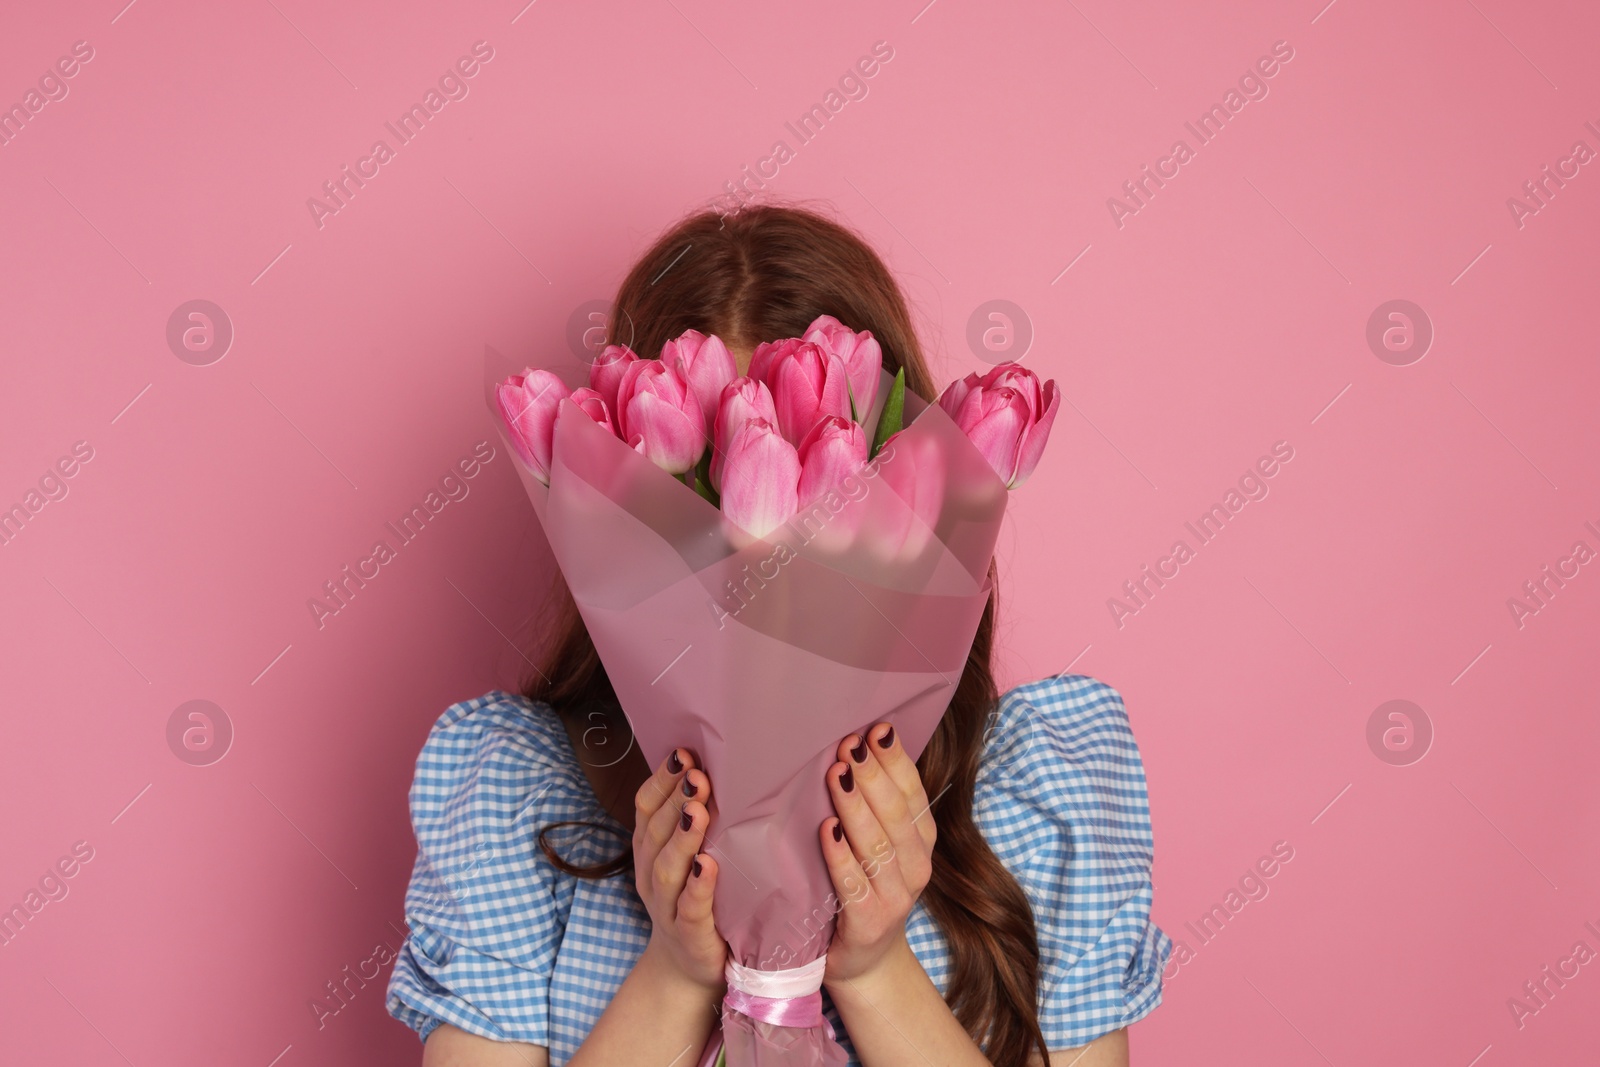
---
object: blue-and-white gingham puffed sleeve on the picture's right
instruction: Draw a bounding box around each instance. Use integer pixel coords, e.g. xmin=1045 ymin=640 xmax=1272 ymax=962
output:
xmin=973 ymin=675 xmax=1171 ymax=1051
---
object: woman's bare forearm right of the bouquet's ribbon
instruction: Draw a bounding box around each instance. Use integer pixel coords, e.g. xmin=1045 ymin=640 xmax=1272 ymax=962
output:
xmin=827 ymin=939 xmax=989 ymax=1067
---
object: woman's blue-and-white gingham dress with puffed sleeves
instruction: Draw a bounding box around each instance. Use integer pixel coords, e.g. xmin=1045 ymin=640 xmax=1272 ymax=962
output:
xmin=386 ymin=675 xmax=1171 ymax=1067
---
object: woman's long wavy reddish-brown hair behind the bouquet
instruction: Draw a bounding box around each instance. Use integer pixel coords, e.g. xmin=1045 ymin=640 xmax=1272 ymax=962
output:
xmin=522 ymin=205 xmax=1050 ymax=1064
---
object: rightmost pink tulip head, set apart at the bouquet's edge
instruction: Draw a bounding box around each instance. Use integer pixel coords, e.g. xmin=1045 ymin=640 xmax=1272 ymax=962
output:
xmin=939 ymin=363 xmax=1061 ymax=490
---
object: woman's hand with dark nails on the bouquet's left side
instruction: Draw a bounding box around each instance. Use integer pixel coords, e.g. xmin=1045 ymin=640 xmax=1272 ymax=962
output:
xmin=634 ymin=749 xmax=728 ymax=990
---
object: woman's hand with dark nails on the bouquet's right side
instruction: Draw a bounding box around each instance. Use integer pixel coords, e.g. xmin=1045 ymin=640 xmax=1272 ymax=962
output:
xmin=821 ymin=723 xmax=934 ymax=984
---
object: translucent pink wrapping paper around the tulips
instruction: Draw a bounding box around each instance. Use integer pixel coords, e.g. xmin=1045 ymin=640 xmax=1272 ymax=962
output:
xmin=485 ymin=352 xmax=1006 ymax=1067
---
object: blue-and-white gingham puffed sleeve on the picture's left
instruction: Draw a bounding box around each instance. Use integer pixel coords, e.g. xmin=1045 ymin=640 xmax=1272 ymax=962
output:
xmin=386 ymin=691 xmax=595 ymax=1048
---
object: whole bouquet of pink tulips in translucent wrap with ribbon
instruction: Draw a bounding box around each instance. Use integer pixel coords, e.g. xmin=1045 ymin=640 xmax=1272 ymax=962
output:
xmin=486 ymin=315 xmax=1059 ymax=1067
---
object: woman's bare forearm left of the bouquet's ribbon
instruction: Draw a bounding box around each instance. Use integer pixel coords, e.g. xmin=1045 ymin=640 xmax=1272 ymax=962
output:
xmin=568 ymin=942 xmax=722 ymax=1067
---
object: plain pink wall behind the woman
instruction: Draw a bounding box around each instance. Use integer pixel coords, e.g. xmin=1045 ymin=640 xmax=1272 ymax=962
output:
xmin=0 ymin=0 xmax=1600 ymax=1067
